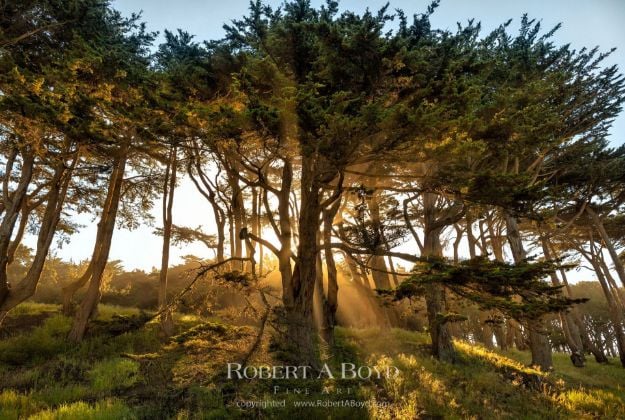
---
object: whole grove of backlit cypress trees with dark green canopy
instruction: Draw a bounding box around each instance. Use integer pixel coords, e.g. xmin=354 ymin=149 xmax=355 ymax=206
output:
xmin=0 ymin=0 xmax=625 ymax=370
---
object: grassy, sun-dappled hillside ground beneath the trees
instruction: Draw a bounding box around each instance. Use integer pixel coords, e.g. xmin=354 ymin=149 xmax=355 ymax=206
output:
xmin=0 ymin=303 xmax=625 ymax=420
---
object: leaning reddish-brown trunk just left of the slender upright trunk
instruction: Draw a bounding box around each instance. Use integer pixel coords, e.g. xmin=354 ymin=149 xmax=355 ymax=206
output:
xmin=68 ymin=151 xmax=128 ymax=341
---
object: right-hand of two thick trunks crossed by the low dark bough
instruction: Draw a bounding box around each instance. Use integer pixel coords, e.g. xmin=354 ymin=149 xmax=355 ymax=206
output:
xmin=505 ymin=213 xmax=553 ymax=371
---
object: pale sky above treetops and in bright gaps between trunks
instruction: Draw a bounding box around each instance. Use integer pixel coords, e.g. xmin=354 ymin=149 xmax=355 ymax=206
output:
xmin=27 ymin=0 xmax=625 ymax=280
